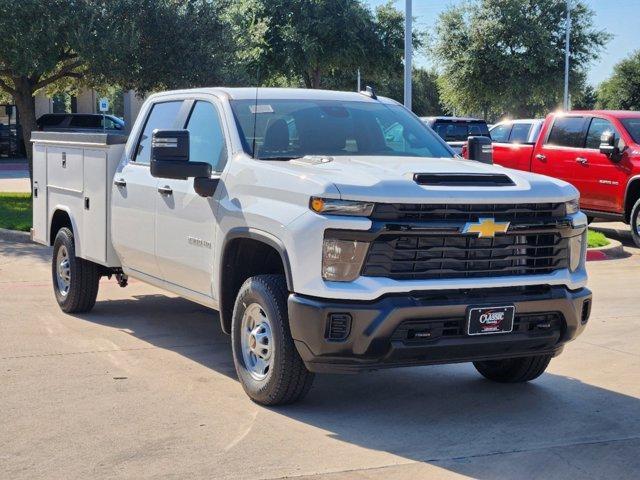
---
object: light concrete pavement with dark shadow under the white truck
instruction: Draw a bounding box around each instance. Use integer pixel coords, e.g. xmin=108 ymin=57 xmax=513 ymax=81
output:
xmin=0 ymin=231 xmax=640 ymax=480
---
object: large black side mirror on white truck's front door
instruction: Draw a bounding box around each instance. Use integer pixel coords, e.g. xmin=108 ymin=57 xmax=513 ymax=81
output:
xmin=151 ymin=130 xmax=211 ymax=180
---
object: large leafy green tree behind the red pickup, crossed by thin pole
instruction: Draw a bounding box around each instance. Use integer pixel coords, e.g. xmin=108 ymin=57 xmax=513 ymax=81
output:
xmin=433 ymin=0 xmax=611 ymax=118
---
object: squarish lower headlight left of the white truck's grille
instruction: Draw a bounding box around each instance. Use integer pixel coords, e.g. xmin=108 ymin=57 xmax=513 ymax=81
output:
xmin=322 ymin=238 xmax=369 ymax=282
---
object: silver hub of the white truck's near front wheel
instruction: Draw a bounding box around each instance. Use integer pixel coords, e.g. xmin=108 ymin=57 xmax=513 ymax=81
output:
xmin=240 ymin=303 xmax=273 ymax=380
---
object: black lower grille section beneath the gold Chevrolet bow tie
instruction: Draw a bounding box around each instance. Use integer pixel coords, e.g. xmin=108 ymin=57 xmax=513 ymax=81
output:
xmin=362 ymin=233 xmax=568 ymax=280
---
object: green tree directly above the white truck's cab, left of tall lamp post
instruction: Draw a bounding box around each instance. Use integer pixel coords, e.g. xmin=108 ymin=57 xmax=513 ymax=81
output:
xmin=252 ymin=0 xmax=412 ymax=90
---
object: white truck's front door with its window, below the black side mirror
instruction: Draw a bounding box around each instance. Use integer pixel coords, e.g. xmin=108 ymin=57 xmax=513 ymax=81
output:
xmin=156 ymin=99 xmax=227 ymax=297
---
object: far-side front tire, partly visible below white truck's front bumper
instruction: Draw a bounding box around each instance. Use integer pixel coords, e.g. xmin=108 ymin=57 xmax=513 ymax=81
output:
xmin=473 ymin=355 xmax=553 ymax=383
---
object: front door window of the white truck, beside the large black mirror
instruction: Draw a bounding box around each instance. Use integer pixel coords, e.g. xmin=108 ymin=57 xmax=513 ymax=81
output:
xmin=187 ymin=101 xmax=226 ymax=172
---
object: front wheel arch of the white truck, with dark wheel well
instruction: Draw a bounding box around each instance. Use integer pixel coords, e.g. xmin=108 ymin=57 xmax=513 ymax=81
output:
xmin=216 ymin=227 xmax=293 ymax=333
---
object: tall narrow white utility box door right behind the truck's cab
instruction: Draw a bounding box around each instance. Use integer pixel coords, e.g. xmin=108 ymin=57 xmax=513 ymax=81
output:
xmin=81 ymin=148 xmax=111 ymax=264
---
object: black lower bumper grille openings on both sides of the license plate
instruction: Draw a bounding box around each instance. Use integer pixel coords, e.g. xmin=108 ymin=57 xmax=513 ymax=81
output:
xmin=391 ymin=312 xmax=564 ymax=345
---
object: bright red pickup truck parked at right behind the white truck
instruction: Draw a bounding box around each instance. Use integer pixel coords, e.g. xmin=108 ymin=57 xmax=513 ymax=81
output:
xmin=484 ymin=110 xmax=640 ymax=247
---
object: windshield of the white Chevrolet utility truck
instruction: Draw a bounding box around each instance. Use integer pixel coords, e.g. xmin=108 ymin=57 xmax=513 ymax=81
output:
xmin=231 ymin=100 xmax=452 ymax=160
